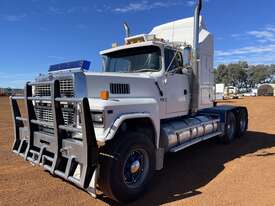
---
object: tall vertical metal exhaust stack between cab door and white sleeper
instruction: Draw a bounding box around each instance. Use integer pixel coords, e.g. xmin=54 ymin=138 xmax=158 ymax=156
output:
xmin=191 ymin=0 xmax=202 ymax=114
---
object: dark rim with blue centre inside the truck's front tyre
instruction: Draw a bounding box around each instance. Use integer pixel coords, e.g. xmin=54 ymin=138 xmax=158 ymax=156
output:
xmin=123 ymin=149 xmax=149 ymax=188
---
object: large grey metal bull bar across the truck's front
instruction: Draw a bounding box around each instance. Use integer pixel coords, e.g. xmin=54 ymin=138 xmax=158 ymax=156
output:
xmin=10 ymin=80 xmax=98 ymax=197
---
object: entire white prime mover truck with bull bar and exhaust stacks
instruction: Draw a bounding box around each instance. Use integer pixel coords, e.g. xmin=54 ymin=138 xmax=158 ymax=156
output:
xmin=10 ymin=1 xmax=248 ymax=202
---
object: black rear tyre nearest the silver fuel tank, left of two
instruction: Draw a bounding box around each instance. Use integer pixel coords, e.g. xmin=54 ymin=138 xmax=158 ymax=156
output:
xmin=221 ymin=111 xmax=237 ymax=144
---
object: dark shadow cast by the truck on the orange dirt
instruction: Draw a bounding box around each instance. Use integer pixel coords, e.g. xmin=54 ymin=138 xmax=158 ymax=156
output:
xmin=99 ymin=131 xmax=275 ymax=206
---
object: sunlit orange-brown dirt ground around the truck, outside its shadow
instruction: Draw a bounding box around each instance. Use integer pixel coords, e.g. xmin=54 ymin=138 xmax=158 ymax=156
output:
xmin=0 ymin=97 xmax=275 ymax=206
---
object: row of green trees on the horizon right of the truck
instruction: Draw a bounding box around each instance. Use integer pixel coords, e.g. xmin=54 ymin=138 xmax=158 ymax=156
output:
xmin=214 ymin=61 xmax=275 ymax=89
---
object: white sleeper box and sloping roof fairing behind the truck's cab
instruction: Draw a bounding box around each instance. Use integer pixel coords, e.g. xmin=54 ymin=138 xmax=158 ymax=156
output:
xmin=150 ymin=17 xmax=215 ymax=109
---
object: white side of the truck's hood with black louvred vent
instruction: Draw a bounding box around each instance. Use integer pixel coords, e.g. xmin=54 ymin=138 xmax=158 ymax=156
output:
xmin=85 ymin=72 xmax=162 ymax=98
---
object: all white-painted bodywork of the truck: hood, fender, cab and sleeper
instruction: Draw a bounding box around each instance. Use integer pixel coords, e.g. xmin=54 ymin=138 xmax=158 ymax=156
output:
xmin=47 ymin=18 xmax=214 ymax=148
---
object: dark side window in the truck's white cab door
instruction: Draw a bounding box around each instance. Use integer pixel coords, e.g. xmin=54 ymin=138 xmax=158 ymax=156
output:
xmin=164 ymin=49 xmax=183 ymax=71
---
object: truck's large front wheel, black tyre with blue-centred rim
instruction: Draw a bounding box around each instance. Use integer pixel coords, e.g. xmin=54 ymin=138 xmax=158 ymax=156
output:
xmin=99 ymin=132 xmax=155 ymax=203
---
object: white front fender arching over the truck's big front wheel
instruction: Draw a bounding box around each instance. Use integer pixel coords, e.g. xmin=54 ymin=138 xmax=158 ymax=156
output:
xmin=89 ymin=98 xmax=160 ymax=143
